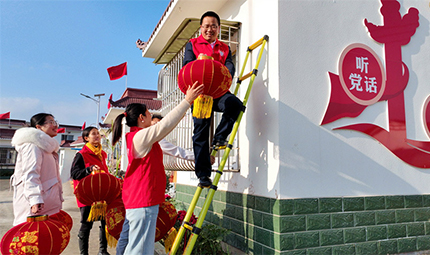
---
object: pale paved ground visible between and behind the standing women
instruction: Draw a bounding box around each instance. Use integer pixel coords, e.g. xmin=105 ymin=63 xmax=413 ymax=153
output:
xmin=0 ymin=179 xmax=165 ymax=255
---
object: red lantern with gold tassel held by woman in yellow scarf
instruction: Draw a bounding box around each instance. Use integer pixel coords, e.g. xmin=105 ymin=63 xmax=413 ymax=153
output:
xmin=75 ymin=170 xmax=121 ymax=221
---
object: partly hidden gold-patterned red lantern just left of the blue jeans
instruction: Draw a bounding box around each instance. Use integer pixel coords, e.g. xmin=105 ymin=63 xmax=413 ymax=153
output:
xmin=105 ymin=197 xmax=125 ymax=247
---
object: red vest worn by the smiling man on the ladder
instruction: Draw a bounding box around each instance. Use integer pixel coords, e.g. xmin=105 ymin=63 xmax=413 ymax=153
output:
xmin=190 ymin=35 xmax=230 ymax=65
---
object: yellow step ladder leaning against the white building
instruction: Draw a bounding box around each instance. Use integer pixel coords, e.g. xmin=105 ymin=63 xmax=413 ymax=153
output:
xmin=169 ymin=35 xmax=269 ymax=255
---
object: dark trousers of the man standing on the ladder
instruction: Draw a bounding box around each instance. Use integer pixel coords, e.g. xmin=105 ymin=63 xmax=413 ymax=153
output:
xmin=193 ymin=92 xmax=244 ymax=178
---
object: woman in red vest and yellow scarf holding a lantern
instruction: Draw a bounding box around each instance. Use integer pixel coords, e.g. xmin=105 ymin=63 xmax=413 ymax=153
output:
xmin=70 ymin=127 xmax=109 ymax=255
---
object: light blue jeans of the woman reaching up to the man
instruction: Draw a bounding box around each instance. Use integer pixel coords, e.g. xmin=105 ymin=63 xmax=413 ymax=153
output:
xmin=124 ymin=205 xmax=159 ymax=255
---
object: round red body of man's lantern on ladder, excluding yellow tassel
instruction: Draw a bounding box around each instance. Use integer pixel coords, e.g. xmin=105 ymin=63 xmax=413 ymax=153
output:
xmin=178 ymin=56 xmax=231 ymax=99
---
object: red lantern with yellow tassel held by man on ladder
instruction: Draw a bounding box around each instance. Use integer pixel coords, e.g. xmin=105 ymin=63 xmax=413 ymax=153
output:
xmin=178 ymin=55 xmax=232 ymax=118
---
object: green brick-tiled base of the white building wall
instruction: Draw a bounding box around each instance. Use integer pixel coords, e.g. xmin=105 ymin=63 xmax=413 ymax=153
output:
xmin=176 ymin=184 xmax=430 ymax=255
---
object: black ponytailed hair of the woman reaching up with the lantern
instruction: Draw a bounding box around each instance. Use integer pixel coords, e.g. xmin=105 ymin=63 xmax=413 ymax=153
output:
xmin=112 ymin=103 xmax=147 ymax=145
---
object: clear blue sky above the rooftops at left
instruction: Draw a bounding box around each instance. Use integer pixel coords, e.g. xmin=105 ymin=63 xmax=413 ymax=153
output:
xmin=0 ymin=0 xmax=170 ymax=126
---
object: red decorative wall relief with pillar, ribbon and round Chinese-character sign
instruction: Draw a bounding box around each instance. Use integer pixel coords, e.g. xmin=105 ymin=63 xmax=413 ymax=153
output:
xmin=321 ymin=0 xmax=430 ymax=168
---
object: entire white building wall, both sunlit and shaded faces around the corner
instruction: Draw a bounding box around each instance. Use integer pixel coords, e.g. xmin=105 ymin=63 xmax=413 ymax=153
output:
xmin=178 ymin=0 xmax=430 ymax=199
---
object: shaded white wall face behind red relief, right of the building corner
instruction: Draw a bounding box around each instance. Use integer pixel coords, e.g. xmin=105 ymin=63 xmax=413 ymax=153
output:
xmin=278 ymin=0 xmax=430 ymax=198
